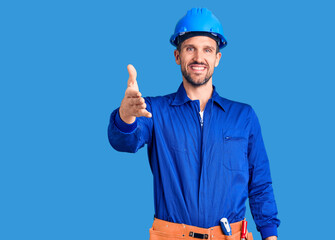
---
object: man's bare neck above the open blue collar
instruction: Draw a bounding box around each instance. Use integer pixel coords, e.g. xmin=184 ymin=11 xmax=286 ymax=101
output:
xmin=183 ymin=79 xmax=213 ymax=111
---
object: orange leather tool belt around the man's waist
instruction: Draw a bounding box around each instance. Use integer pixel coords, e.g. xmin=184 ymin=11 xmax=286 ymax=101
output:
xmin=149 ymin=218 xmax=253 ymax=240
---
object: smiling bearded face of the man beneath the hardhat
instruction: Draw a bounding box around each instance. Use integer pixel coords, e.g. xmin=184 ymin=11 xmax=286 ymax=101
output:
xmin=174 ymin=36 xmax=221 ymax=87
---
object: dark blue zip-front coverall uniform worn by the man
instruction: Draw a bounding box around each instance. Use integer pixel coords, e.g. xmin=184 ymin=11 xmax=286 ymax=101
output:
xmin=108 ymin=84 xmax=280 ymax=239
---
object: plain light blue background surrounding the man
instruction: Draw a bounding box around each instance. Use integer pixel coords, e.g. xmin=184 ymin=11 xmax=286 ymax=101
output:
xmin=0 ymin=0 xmax=335 ymax=240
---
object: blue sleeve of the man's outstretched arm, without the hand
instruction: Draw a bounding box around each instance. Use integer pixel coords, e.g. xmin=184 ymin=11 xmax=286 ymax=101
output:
xmin=108 ymin=97 xmax=153 ymax=153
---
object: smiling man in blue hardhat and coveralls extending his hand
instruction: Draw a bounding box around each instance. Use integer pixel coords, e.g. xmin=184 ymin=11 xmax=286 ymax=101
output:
xmin=108 ymin=8 xmax=280 ymax=240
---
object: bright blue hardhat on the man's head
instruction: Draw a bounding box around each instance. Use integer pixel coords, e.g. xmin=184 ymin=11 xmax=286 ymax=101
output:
xmin=170 ymin=8 xmax=227 ymax=49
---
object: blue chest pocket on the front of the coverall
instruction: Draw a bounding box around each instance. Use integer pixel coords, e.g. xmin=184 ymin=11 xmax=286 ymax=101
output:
xmin=223 ymin=129 xmax=248 ymax=171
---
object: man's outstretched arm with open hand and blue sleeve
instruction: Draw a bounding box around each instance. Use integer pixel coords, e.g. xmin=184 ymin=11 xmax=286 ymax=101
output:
xmin=108 ymin=65 xmax=153 ymax=152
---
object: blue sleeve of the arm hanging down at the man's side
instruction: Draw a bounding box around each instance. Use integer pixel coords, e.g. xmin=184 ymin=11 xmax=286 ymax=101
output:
xmin=248 ymin=108 xmax=280 ymax=239
